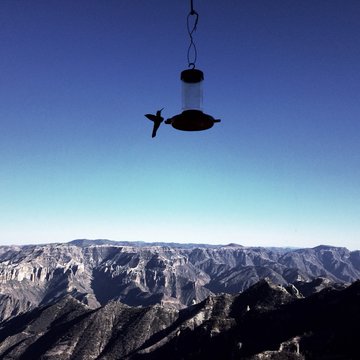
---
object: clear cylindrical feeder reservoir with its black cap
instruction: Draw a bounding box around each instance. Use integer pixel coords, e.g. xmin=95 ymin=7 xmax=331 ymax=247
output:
xmin=181 ymin=69 xmax=204 ymax=111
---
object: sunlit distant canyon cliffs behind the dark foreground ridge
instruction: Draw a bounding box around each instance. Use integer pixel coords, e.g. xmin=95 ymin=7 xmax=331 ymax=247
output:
xmin=0 ymin=240 xmax=360 ymax=321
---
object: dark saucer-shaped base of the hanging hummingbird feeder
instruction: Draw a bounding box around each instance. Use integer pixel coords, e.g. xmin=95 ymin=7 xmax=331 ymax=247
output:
xmin=165 ymin=110 xmax=220 ymax=131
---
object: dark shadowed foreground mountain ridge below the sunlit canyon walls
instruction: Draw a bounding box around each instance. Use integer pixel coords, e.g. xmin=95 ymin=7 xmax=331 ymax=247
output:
xmin=0 ymin=280 xmax=360 ymax=360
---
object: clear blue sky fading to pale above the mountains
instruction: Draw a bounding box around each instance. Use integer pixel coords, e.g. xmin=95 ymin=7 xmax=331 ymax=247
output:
xmin=0 ymin=0 xmax=360 ymax=249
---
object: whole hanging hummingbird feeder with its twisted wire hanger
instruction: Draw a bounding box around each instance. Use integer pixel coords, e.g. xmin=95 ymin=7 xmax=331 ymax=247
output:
xmin=165 ymin=0 xmax=220 ymax=131
